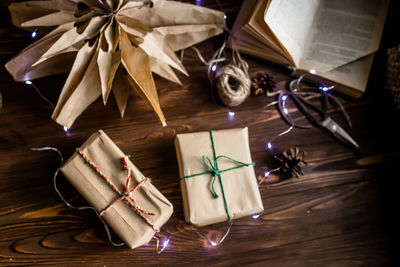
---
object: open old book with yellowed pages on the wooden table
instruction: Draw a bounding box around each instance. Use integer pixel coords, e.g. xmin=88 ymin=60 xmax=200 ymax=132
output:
xmin=228 ymin=0 xmax=389 ymax=97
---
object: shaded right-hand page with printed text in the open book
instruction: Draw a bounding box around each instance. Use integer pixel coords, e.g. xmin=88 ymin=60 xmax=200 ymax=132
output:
xmin=299 ymin=0 xmax=389 ymax=72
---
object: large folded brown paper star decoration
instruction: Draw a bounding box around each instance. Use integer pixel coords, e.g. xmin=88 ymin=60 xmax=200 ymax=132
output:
xmin=6 ymin=0 xmax=225 ymax=127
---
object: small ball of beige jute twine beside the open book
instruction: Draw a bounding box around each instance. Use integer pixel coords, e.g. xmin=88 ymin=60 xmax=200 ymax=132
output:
xmin=215 ymin=64 xmax=251 ymax=107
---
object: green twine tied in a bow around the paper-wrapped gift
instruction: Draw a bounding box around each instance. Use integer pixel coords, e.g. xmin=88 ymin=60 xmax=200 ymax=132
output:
xmin=179 ymin=130 xmax=255 ymax=222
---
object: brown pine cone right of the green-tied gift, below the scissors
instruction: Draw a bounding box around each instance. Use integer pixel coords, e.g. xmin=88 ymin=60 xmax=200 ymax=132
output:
xmin=278 ymin=147 xmax=308 ymax=178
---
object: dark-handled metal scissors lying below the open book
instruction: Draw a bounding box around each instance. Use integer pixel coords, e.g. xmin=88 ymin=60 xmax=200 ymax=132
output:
xmin=278 ymin=76 xmax=360 ymax=150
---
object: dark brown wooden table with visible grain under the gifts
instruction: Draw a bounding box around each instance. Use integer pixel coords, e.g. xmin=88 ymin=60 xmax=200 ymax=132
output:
xmin=0 ymin=0 xmax=400 ymax=266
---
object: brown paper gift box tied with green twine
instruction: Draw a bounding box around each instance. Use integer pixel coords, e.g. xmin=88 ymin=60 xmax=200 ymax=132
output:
xmin=175 ymin=127 xmax=264 ymax=226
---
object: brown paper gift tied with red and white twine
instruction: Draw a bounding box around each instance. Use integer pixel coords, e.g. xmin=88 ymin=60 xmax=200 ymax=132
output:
xmin=61 ymin=130 xmax=173 ymax=249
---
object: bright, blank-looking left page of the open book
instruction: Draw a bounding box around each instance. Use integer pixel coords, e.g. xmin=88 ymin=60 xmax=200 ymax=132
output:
xmin=264 ymin=0 xmax=321 ymax=67
